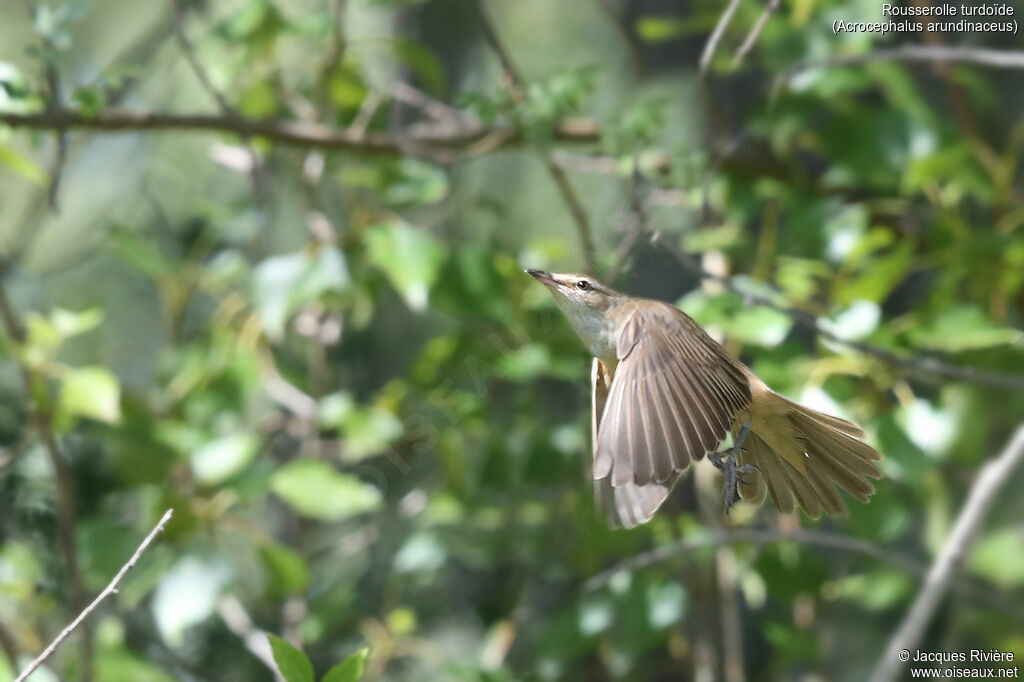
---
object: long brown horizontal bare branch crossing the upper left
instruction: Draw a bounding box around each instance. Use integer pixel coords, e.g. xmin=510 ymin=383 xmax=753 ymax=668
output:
xmin=0 ymin=110 xmax=601 ymax=163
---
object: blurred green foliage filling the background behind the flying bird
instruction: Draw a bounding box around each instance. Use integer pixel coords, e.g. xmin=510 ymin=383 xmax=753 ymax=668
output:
xmin=0 ymin=0 xmax=1024 ymax=682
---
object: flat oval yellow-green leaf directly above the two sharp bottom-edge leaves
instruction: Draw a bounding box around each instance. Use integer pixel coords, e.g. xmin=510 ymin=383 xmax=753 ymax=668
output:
xmin=270 ymin=459 xmax=381 ymax=521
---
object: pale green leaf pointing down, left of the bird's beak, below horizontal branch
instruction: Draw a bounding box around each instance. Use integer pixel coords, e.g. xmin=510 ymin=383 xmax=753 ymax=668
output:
xmin=367 ymin=221 xmax=444 ymax=312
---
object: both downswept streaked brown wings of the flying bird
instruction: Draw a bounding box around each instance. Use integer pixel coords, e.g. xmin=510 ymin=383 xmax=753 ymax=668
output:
xmin=593 ymin=304 xmax=751 ymax=525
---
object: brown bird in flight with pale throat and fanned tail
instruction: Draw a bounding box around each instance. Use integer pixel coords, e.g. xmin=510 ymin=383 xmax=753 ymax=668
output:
xmin=526 ymin=270 xmax=882 ymax=528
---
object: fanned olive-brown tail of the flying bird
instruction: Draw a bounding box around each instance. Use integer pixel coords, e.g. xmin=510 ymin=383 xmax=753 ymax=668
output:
xmin=739 ymin=390 xmax=882 ymax=518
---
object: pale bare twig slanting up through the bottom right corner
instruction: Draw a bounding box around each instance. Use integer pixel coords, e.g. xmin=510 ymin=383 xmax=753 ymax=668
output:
xmin=871 ymin=424 xmax=1024 ymax=682
